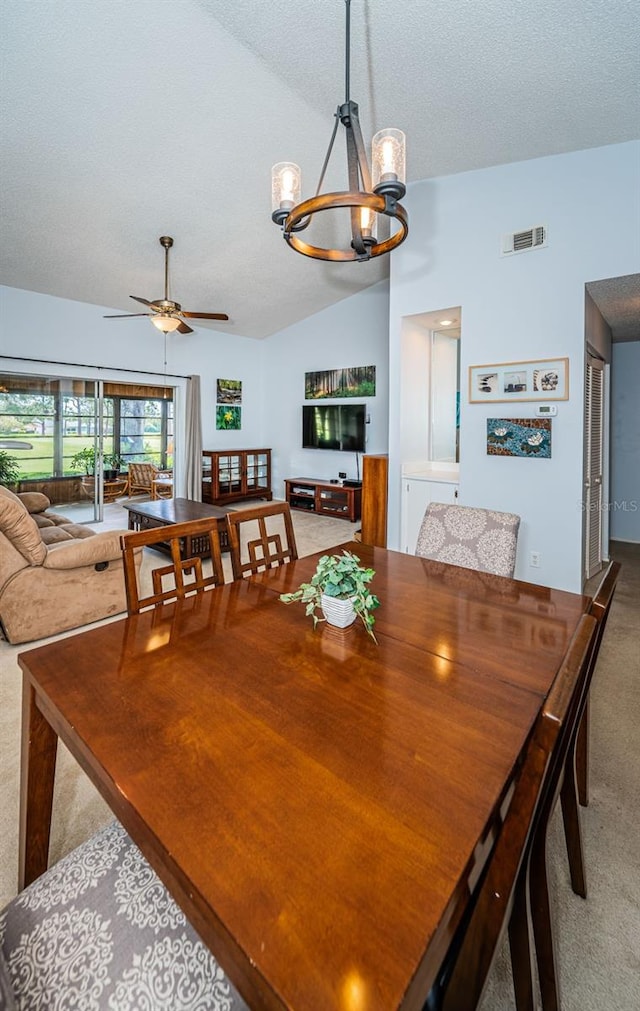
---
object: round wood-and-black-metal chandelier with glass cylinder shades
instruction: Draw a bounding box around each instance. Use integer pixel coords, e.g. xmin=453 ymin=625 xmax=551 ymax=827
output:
xmin=271 ymin=0 xmax=408 ymax=261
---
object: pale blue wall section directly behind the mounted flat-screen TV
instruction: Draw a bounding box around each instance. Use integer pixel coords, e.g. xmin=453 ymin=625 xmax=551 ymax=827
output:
xmin=264 ymin=281 xmax=389 ymax=497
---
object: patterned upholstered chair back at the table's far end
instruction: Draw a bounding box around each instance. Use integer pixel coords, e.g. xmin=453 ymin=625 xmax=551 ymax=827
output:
xmin=416 ymin=502 xmax=520 ymax=577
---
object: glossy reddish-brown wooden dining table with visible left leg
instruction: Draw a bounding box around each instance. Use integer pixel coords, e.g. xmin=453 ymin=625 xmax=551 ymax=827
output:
xmin=19 ymin=543 xmax=589 ymax=1011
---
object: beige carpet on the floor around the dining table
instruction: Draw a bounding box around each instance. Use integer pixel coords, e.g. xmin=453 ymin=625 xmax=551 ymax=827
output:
xmin=0 ymin=511 xmax=640 ymax=1011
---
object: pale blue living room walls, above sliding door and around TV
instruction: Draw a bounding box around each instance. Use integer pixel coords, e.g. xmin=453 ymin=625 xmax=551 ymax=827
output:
xmin=0 ymin=282 xmax=388 ymax=497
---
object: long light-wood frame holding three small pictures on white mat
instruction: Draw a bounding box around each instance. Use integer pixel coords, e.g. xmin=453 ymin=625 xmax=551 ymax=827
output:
xmin=469 ymin=358 xmax=569 ymax=403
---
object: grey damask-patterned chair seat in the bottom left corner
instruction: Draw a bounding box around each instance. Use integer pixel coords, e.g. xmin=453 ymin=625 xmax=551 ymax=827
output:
xmin=0 ymin=822 xmax=248 ymax=1011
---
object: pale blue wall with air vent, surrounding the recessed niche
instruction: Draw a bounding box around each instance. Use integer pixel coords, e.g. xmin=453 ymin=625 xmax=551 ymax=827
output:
xmin=389 ymin=143 xmax=640 ymax=590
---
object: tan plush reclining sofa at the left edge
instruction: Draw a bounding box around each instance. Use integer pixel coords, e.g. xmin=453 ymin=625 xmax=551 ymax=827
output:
xmin=0 ymin=485 xmax=142 ymax=643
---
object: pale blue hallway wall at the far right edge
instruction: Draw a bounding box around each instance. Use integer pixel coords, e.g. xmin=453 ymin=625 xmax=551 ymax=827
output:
xmin=610 ymin=340 xmax=640 ymax=544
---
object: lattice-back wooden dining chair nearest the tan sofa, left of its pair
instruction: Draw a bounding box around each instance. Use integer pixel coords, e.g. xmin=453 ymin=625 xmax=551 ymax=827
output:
xmin=120 ymin=517 xmax=224 ymax=615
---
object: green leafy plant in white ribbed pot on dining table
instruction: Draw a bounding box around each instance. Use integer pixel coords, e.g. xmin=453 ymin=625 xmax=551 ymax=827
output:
xmin=280 ymin=551 xmax=380 ymax=642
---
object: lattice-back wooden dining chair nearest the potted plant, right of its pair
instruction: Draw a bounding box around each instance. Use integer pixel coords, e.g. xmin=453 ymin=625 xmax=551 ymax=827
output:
xmin=226 ymin=502 xmax=298 ymax=579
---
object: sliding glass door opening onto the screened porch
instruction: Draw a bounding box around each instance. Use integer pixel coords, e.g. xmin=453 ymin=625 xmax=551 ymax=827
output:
xmin=0 ymin=373 xmax=174 ymax=523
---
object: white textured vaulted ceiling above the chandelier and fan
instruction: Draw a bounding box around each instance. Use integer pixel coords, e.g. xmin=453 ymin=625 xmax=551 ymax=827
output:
xmin=0 ymin=0 xmax=640 ymax=337
